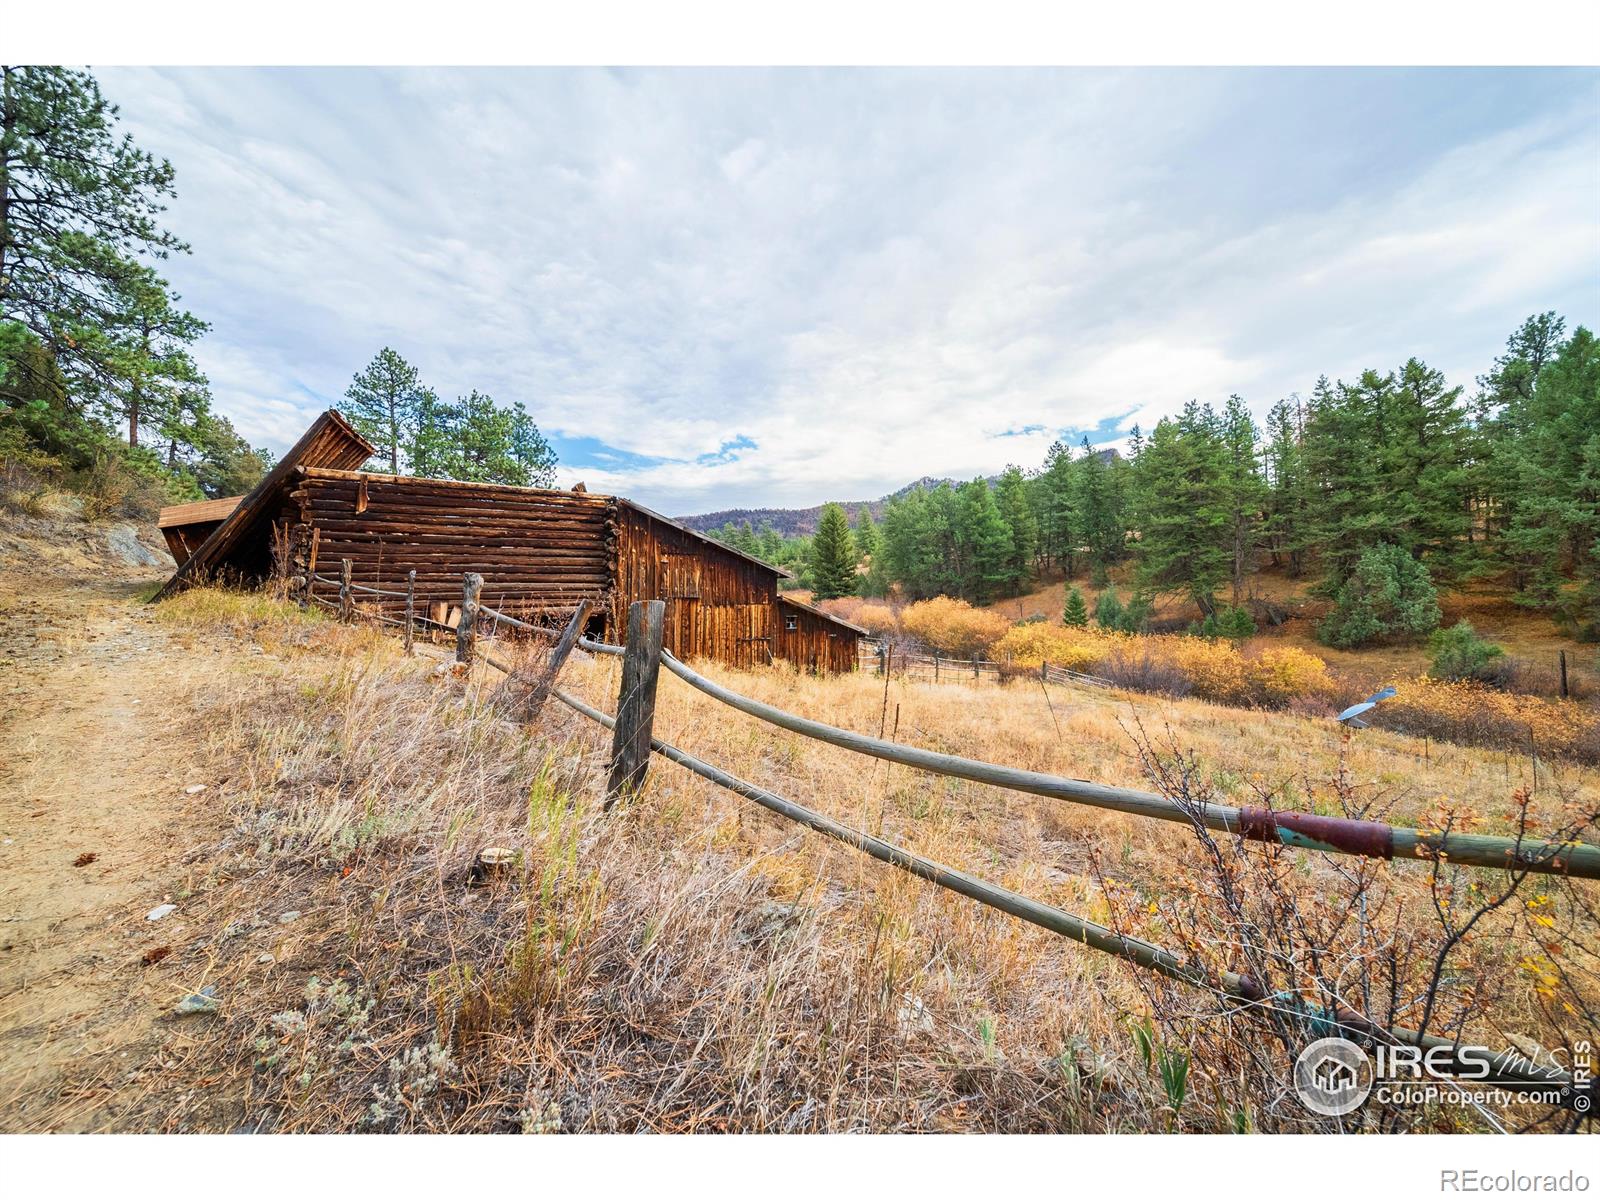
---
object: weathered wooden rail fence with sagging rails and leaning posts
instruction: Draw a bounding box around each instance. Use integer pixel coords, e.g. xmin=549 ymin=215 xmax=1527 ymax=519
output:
xmin=307 ymin=563 xmax=1600 ymax=1112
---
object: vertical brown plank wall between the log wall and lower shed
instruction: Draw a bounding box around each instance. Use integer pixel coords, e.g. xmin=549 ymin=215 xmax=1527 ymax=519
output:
xmin=608 ymin=501 xmax=778 ymax=667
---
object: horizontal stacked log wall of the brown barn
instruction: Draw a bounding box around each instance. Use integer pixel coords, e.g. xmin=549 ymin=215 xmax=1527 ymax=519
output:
xmin=290 ymin=469 xmax=616 ymax=616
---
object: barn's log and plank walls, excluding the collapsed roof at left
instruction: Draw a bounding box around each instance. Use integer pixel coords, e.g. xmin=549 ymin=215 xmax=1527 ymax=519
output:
xmin=286 ymin=467 xmax=856 ymax=672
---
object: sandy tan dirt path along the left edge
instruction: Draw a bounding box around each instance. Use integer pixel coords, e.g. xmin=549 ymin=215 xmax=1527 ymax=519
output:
xmin=0 ymin=570 xmax=233 ymax=1131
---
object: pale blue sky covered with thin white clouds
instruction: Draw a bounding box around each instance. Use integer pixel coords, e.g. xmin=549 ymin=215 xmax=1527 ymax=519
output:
xmin=98 ymin=69 xmax=1600 ymax=514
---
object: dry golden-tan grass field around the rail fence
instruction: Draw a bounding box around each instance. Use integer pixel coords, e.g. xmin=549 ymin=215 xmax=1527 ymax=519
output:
xmin=150 ymin=589 xmax=1597 ymax=1131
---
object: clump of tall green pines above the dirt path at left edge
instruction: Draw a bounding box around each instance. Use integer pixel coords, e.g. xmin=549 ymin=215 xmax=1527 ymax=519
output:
xmin=0 ymin=67 xmax=264 ymax=499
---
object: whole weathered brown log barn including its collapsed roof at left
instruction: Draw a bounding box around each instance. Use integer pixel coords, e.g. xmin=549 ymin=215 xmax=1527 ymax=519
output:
xmin=157 ymin=410 xmax=866 ymax=672
